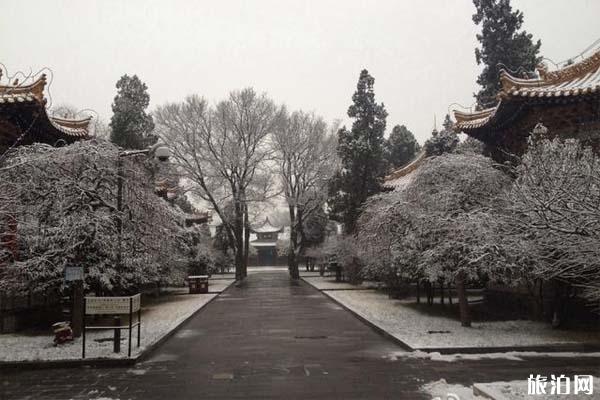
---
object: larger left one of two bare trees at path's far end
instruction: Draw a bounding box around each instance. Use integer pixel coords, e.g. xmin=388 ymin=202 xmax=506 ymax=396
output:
xmin=154 ymin=88 xmax=280 ymax=281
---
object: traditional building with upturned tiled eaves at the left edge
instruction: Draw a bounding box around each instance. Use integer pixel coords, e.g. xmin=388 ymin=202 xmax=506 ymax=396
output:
xmin=0 ymin=74 xmax=91 ymax=155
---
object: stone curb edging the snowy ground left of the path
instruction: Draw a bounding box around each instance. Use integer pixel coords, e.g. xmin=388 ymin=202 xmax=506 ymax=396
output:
xmin=0 ymin=281 xmax=234 ymax=371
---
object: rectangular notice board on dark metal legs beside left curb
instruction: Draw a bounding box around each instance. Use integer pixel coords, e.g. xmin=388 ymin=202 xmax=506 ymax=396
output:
xmin=81 ymin=293 xmax=142 ymax=358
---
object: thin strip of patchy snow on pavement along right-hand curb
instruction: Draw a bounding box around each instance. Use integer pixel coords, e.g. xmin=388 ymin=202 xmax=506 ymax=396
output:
xmin=385 ymin=350 xmax=600 ymax=362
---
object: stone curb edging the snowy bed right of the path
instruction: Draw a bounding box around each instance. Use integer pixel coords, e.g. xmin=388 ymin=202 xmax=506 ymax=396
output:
xmin=301 ymin=277 xmax=600 ymax=354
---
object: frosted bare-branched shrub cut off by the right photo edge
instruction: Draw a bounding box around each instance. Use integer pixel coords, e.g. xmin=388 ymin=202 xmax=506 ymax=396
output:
xmin=498 ymin=138 xmax=600 ymax=303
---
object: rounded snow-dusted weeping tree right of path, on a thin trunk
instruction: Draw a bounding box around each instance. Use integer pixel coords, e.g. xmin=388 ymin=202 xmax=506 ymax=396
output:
xmin=358 ymin=153 xmax=512 ymax=323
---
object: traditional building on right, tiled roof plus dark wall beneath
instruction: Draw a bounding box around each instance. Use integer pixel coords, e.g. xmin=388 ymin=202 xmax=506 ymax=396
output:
xmin=454 ymin=50 xmax=600 ymax=161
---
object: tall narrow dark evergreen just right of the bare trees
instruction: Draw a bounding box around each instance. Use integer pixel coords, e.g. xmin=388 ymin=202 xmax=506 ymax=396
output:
xmin=328 ymin=69 xmax=387 ymax=233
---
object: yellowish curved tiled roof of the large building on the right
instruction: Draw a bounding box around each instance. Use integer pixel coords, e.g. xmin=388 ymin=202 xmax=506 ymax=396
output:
xmin=454 ymin=50 xmax=600 ymax=131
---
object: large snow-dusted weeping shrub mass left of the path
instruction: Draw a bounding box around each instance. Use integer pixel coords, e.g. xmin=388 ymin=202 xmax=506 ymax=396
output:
xmin=0 ymin=140 xmax=202 ymax=293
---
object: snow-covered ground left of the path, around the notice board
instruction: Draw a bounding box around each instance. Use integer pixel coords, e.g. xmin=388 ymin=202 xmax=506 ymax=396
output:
xmin=0 ymin=280 xmax=233 ymax=362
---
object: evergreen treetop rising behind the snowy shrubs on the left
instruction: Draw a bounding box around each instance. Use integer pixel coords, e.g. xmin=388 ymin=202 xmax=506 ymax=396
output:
xmin=110 ymin=75 xmax=157 ymax=149
